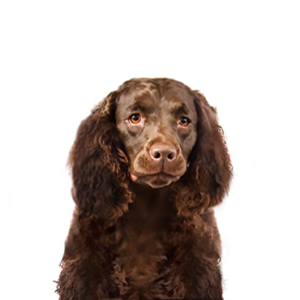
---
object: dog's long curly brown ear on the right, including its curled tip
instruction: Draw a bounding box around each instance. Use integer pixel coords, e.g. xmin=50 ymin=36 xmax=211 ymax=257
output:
xmin=173 ymin=91 xmax=233 ymax=215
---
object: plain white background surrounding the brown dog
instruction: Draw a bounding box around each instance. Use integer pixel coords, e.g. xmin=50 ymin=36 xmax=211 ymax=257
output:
xmin=0 ymin=0 xmax=300 ymax=300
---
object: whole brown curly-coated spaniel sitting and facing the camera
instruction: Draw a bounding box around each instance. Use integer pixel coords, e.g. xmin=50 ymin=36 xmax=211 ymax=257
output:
xmin=57 ymin=78 xmax=232 ymax=300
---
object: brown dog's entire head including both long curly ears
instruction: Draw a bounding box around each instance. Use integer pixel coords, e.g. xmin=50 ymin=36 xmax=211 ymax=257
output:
xmin=69 ymin=78 xmax=232 ymax=216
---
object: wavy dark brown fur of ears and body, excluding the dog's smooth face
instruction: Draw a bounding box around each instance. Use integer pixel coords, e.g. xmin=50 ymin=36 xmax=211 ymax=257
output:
xmin=57 ymin=79 xmax=232 ymax=300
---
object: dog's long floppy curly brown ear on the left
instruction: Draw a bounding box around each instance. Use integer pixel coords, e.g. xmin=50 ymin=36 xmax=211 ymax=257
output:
xmin=68 ymin=92 xmax=131 ymax=220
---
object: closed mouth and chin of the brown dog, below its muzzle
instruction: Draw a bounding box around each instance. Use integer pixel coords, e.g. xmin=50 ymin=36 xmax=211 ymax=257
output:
xmin=130 ymin=172 xmax=180 ymax=188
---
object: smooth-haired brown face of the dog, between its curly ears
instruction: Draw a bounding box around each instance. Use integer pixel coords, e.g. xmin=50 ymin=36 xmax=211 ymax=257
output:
xmin=116 ymin=82 xmax=198 ymax=188
